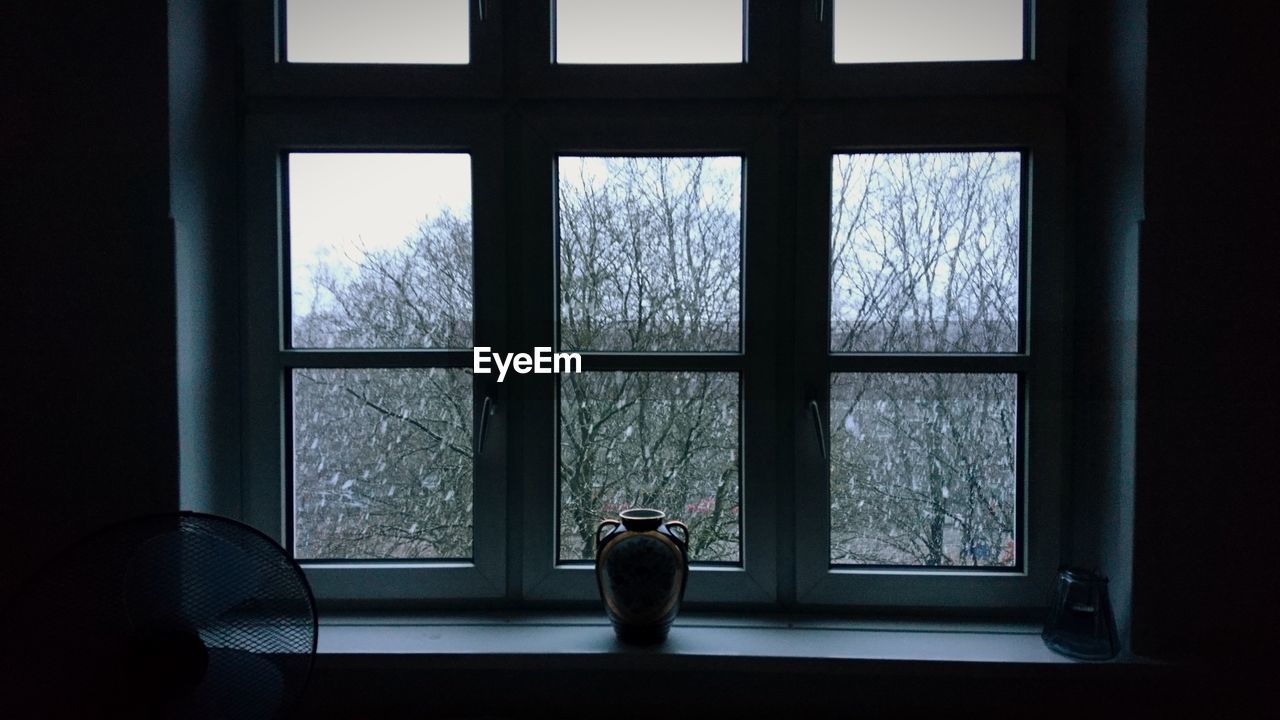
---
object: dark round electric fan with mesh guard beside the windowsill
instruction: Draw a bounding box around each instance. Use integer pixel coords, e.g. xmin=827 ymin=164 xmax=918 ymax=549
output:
xmin=0 ymin=512 xmax=316 ymax=719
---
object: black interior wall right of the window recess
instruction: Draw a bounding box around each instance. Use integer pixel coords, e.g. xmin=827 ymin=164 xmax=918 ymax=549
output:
xmin=1134 ymin=3 xmax=1280 ymax=665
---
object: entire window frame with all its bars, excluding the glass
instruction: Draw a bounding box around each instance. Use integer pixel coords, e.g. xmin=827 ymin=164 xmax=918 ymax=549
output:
xmin=238 ymin=0 xmax=1073 ymax=615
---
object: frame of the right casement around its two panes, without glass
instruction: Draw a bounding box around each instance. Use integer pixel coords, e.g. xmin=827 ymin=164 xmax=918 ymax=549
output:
xmin=794 ymin=100 xmax=1069 ymax=610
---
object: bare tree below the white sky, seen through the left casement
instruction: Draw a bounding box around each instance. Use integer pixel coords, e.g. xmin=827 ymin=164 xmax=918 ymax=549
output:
xmin=293 ymin=211 xmax=472 ymax=559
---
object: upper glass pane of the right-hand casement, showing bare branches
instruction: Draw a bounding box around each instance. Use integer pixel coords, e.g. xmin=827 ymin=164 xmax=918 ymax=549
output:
xmin=831 ymin=152 xmax=1021 ymax=352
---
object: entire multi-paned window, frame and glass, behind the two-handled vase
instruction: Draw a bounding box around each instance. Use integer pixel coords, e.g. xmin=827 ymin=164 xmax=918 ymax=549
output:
xmin=242 ymin=0 xmax=1070 ymax=611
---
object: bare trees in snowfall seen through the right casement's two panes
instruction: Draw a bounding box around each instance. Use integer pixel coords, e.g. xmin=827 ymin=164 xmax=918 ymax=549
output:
xmin=831 ymin=152 xmax=1020 ymax=565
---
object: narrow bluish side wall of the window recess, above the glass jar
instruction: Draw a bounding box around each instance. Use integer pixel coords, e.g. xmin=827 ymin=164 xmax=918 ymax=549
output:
xmin=1066 ymin=0 xmax=1147 ymax=647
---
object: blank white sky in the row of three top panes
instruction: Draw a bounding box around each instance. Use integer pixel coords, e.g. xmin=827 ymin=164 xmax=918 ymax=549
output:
xmin=285 ymin=0 xmax=1023 ymax=64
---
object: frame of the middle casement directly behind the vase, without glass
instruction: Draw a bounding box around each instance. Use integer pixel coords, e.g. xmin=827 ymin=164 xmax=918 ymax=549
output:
xmin=513 ymin=104 xmax=777 ymax=605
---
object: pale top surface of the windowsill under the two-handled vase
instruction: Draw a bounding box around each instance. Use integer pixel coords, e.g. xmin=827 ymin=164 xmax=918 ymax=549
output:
xmin=319 ymin=612 xmax=1146 ymax=669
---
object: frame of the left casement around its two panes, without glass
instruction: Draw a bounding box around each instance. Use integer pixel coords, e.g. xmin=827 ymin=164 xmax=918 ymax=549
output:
xmin=241 ymin=110 xmax=508 ymax=603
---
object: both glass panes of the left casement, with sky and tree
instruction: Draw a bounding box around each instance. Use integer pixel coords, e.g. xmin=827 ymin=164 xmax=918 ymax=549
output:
xmin=285 ymin=152 xmax=474 ymax=560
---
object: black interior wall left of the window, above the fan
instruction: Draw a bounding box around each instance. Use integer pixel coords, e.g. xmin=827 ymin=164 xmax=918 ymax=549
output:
xmin=0 ymin=0 xmax=178 ymax=597
